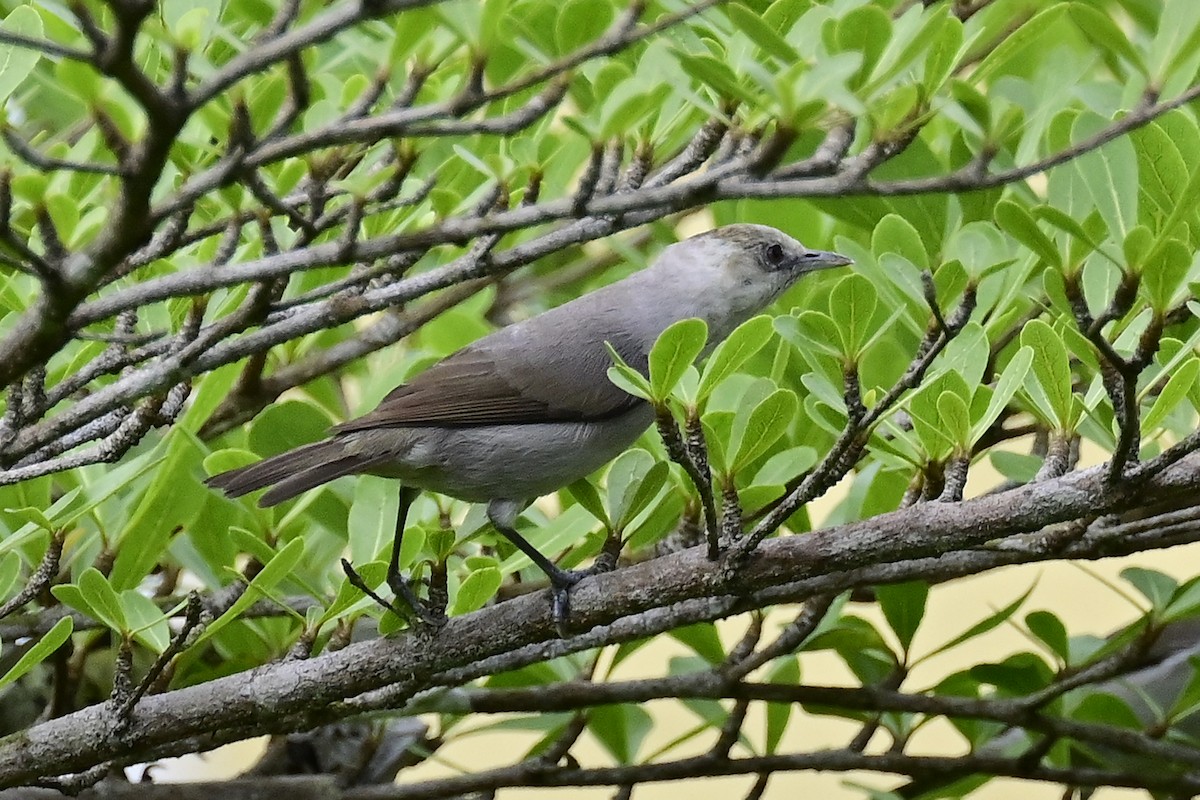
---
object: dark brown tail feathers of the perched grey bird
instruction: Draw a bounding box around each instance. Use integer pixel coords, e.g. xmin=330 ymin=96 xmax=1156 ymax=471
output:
xmin=204 ymin=439 xmax=371 ymax=507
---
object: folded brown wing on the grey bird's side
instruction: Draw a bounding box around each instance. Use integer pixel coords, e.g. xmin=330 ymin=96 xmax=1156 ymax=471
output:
xmin=334 ymin=321 xmax=644 ymax=433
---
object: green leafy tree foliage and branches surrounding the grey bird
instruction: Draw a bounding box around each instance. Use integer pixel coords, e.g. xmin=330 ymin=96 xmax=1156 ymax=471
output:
xmin=0 ymin=0 xmax=1200 ymax=798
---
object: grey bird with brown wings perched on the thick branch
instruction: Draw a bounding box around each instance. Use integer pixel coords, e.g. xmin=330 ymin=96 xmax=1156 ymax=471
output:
xmin=208 ymin=224 xmax=851 ymax=626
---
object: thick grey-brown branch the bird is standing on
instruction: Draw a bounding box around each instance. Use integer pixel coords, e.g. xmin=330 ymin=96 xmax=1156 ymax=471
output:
xmin=0 ymin=458 xmax=1200 ymax=786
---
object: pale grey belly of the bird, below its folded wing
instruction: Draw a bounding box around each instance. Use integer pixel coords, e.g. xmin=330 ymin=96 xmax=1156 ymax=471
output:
xmin=355 ymin=405 xmax=654 ymax=503
